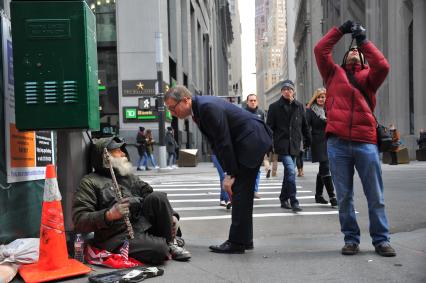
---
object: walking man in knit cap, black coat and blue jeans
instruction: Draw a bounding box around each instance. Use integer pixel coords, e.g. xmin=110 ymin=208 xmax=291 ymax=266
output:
xmin=267 ymin=80 xmax=311 ymax=212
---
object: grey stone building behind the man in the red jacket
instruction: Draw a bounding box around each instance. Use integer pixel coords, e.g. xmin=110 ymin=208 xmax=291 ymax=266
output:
xmin=294 ymin=0 xmax=426 ymax=159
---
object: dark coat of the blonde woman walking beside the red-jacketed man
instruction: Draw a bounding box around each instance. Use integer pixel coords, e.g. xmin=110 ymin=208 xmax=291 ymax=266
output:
xmin=306 ymin=108 xmax=328 ymax=162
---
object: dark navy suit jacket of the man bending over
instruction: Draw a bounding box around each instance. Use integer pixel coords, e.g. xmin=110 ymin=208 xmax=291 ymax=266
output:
xmin=192 ymin=96 xmax=272 ymax=176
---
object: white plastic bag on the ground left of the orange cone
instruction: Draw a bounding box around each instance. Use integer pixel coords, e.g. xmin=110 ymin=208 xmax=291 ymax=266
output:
xmin=0 ymin=238 xmax=40 ymax=264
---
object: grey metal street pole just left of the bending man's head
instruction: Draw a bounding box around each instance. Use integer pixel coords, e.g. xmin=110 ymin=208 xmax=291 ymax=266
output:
xmin=155 ymin=31 xmax=167 ymax=169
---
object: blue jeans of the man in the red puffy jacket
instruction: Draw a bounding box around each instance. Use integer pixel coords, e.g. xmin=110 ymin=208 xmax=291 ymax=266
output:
xmin=327 ymin=137 xmax=389 ymax=246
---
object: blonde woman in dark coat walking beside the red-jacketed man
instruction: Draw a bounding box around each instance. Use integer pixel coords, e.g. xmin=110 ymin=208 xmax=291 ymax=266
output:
xmin=306 ymin=88 xmax=337 ymax=207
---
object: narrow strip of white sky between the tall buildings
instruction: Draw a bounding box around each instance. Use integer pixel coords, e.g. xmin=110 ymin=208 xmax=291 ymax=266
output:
xmin=238 ymin=0 xmax=256 ymax=98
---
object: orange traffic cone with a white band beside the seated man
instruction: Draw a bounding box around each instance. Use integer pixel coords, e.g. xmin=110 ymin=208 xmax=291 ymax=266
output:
xmin=19 ymin=164 xmax=91 ymax=283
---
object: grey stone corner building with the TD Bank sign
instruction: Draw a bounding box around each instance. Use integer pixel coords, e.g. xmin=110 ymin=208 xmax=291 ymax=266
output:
xmin=87 ymin=0 xmax=235 ymax=161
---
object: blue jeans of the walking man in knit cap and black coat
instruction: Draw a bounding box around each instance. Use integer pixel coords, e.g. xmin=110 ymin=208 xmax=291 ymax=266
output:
xmin=280 ymin=155 xmax=299 ymax=206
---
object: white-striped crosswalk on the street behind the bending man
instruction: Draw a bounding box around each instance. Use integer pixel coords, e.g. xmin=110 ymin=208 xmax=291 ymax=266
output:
xmin=152 ymin=178 xmax=338 ymax=221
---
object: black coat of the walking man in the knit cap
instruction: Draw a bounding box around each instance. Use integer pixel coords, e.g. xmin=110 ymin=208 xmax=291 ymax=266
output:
xmin=267 ymin=96 xmax=311 ymax=156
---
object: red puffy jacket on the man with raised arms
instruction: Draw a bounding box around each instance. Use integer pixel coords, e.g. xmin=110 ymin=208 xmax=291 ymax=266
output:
xmin=314 ymin=27 xmax=390 ymax=144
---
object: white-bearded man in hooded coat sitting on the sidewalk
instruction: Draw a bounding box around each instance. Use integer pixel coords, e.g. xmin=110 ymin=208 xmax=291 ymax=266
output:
xmin=72 ymin=137 xmax=191 ymax=264
